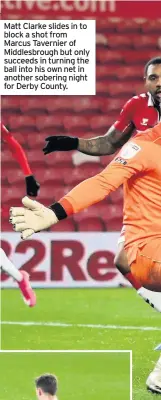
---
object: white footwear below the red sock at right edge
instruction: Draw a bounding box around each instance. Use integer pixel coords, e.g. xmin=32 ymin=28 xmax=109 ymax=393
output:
xmin=137 ymin=287 xmax=161 ymax=312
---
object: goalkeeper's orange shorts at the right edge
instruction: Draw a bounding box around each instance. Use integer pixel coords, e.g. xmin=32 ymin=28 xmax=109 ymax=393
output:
xmin=131 ymin=238 xmax=161 ymax=292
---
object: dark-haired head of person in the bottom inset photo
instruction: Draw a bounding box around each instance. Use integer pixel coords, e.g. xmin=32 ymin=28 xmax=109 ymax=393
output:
xmin=35 ymin=374 xmax=58 ymax=400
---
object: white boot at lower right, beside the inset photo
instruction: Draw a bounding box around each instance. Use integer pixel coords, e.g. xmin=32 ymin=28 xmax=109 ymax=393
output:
xmin=146 ymin=344 xmax=161 ymax=393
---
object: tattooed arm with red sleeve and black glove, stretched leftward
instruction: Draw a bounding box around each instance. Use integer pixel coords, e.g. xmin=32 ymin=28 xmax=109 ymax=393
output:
xmin=43 ymin=98 xmax=136 ymax=156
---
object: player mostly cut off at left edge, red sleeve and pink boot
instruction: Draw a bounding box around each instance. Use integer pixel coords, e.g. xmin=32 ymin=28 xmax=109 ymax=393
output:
xmin=0 ymin=123 xmax=40 ymax=307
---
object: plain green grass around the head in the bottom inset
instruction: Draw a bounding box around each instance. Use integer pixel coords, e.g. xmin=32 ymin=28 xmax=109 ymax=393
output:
xmin=0 ymin=353 xmax=130 ymax=400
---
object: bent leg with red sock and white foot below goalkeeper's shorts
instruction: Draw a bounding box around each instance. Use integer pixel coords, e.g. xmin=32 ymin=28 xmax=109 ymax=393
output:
xmin=114 ymin=241 xmax=161 ymax=312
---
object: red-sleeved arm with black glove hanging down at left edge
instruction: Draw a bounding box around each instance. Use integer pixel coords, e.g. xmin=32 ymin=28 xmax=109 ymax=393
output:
xmin=1 ymin=124 xmax=40 ymax=196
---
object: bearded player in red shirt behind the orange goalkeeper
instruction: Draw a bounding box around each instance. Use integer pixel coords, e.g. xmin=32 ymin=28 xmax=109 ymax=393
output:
xmin=43 ymin=57 xmax=161 ymax=309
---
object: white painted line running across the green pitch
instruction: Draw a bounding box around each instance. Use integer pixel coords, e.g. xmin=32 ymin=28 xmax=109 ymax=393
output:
xmin=1 ymin=321 xmax=161 ymax=331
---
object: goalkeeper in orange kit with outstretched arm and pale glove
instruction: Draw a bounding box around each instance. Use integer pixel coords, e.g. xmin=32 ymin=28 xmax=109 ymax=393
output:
xmin=10 ymin=123 xmax=161 ymax=292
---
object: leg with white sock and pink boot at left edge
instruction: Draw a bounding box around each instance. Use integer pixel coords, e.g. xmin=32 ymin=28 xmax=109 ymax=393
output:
xmin=0 ymin=249 xmax=36 ymax=307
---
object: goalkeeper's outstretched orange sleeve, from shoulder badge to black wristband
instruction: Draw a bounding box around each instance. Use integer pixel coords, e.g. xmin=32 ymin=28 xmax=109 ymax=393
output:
xmin=54 ymin=141 xmax=147 ymax=219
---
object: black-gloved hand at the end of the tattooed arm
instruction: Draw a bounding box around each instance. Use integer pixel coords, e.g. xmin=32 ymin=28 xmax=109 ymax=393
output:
xmin=43 ymin=136 xmax=79 ymax=154
